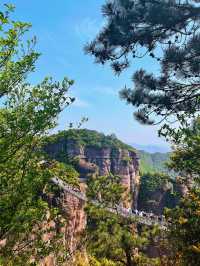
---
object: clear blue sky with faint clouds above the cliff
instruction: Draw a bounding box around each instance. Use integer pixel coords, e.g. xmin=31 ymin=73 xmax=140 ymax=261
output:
xmin=12 ymin=0 xmax=170 ymax=151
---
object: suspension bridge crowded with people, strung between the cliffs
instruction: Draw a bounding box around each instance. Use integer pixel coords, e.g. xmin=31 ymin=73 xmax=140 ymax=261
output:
xmin=51 ymin=177 xmax=167 ymax=230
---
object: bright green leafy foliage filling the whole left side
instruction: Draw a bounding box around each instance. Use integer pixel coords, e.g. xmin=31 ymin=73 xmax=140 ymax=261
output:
xmin=0 ymin=5 xmax=75 ymax=266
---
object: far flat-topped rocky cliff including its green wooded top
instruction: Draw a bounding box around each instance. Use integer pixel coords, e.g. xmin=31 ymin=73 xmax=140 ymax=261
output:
xmin=45 ymin=130 xmax=140 ymax=208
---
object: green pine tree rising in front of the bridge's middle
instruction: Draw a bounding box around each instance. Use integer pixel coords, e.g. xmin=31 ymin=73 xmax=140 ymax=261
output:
xmin=86 ymin=176 xmax=155 ymax=266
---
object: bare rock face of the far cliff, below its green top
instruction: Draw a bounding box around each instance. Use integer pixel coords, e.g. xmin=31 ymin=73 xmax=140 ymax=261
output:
xmin=45 ymin=137 xmax=140 ymax=208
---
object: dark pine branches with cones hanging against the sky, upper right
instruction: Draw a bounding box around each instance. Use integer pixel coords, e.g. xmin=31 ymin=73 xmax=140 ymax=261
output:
xmin=85 ymin=0 xmax=200 ymax=128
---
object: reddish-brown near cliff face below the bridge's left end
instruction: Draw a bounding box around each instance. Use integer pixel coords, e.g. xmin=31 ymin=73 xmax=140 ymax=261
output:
xmin=40 ymin=187 xmax=86 ymax=266
